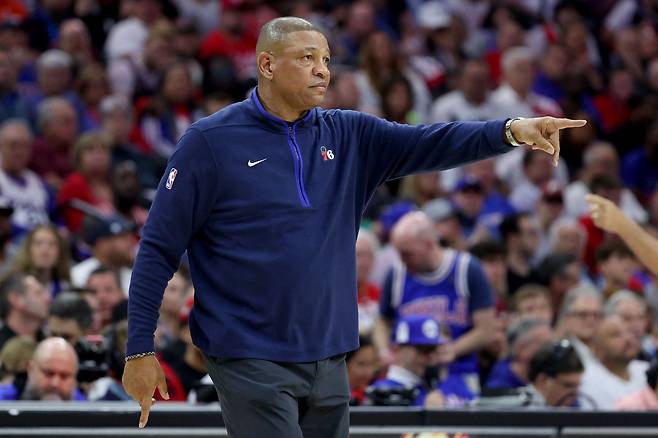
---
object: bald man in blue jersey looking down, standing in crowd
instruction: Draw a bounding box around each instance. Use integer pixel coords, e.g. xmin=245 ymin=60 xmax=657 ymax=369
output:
xmin=375 ymin=211 xmax=496 ymax=392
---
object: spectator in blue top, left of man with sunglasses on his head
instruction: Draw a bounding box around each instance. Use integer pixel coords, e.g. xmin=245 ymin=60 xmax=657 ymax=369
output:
xmin=486 ymin=318 xmax=553 ymax=389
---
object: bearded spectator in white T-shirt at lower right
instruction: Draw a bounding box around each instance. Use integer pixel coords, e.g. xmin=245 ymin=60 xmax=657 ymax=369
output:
xmin=581 ymin=315 xmax=648 ymax=409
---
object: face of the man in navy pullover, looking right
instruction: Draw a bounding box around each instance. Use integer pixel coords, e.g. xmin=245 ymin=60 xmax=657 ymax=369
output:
xmin=271 ymin=31 xmax=330 ymax=111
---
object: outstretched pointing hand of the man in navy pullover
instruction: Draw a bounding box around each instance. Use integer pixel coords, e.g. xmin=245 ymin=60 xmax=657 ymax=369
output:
xmin=510 ymin=117 xmax=587 ymax=166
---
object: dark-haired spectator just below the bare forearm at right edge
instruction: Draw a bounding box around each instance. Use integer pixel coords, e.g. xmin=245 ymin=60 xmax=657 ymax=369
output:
xmin=596 ymin=240 xmax=642 ymax=298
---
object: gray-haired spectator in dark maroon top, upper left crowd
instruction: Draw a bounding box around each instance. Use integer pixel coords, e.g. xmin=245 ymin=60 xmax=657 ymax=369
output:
xmin=30 ymin=97 xmax=78 ymax=189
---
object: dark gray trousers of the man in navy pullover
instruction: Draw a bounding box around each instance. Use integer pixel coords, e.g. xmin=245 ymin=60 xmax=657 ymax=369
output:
xmin=205 ymin=355 xmax=350 ymax=438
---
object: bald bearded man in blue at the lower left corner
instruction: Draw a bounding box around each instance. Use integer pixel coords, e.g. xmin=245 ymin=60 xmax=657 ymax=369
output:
xmin=0 ymin=337 xmax=85 ymax=401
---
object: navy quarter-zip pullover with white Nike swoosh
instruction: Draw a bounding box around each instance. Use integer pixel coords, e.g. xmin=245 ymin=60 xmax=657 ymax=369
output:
xmin=126 ymin=91 xmax=513 ymax=362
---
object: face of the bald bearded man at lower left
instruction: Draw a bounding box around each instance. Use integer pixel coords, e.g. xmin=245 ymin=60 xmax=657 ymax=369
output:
xmin=26 ymin=352 xmax=78 ymax=400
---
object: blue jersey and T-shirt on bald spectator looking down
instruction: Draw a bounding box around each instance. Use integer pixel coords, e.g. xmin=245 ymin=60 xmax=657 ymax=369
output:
xmin=380 ymin=249 xmax=493 ymax=374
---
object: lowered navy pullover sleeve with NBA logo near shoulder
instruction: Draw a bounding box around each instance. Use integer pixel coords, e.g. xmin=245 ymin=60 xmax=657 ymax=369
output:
xmin=126 ymin=128 xmax=218 ymax=355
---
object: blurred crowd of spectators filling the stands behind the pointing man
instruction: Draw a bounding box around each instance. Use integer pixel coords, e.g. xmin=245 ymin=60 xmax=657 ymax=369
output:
xmin=0 ymin=0 xmax=658 ymax=409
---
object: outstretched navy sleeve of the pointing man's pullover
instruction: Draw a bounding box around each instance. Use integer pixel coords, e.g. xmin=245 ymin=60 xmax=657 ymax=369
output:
xmin=344 ymin=111 xmax=514 ymax=191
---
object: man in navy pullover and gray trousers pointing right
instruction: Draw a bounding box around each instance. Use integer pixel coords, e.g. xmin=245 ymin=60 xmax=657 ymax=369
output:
xmin=123 ymin=17 xmax=584 ymax=438
